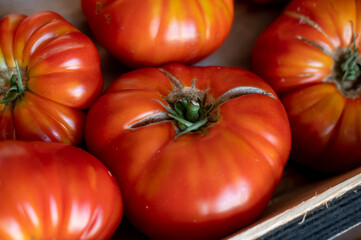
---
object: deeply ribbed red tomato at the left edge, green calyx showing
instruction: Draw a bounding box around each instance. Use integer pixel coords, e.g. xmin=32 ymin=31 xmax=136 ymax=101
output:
xmin=0 ymin=12 xmax=103 ymax=145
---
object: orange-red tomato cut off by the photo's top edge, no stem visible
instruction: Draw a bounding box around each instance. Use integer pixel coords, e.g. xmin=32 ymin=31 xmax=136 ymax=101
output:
xmin=81 ymin=0 xmax=234 ymax=67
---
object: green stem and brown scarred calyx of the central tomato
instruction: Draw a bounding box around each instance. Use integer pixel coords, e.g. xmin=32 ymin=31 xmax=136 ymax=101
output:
xmin=129 ymin=69 xmax=276 ymax=140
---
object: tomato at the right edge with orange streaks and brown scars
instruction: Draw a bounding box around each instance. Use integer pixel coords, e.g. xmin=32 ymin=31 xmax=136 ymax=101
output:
xmin=252 ymin=0 xmax=361 ymax=172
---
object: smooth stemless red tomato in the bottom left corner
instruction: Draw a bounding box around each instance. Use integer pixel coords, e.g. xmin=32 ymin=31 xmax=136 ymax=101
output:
xmin=0 ymin=141 xmax=123 ymax=240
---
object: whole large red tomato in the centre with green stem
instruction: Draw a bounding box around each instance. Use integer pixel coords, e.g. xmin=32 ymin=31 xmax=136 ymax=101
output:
xmin=85 ymin=64 xmax=291 ymax=239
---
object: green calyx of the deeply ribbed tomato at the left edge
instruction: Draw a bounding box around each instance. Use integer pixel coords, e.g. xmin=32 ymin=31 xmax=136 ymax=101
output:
xmin=0 ymin=61 xmax=24 ymax=111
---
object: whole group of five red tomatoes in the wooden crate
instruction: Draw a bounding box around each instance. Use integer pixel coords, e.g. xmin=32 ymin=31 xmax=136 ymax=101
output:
xmin=0 ymin=0 xmax=361 ymax=239
